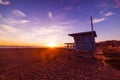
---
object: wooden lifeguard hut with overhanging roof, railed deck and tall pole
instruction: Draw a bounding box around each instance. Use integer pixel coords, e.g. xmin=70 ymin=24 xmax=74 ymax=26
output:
xmin=65 ymin=17 xmax=97 ymax=58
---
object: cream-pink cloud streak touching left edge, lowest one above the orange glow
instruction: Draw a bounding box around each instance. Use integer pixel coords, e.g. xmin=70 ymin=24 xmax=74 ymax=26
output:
xmin=0 ymin=24 xmax=21 ymax=33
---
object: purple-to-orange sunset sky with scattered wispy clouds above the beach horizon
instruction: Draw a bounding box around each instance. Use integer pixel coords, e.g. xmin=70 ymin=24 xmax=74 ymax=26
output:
xmin=0 ymin=0 xmax=120 ymax=47
